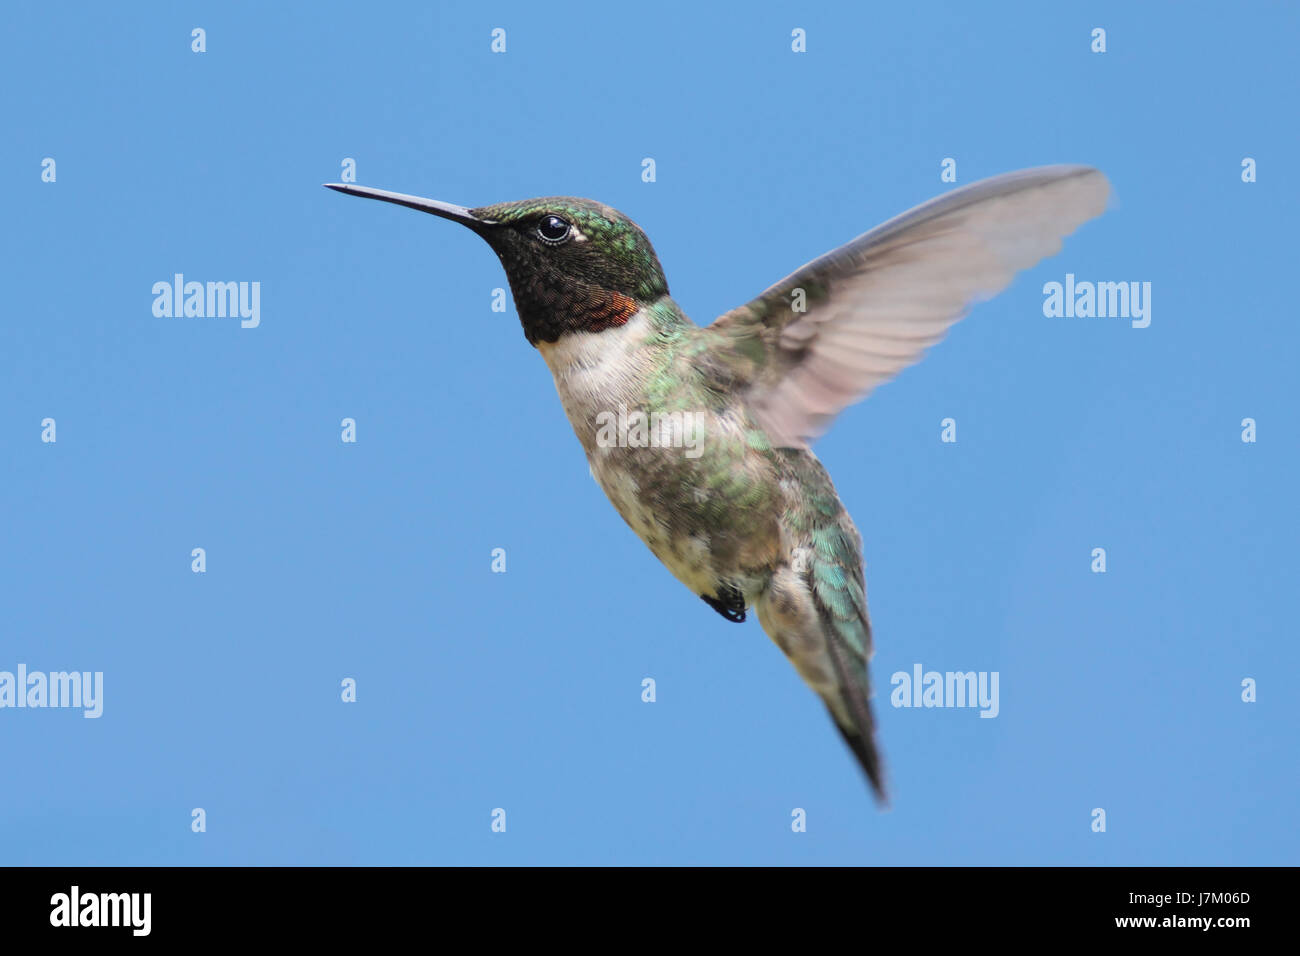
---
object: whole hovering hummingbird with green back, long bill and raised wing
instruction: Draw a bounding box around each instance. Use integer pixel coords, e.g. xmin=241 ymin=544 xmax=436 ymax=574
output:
xmin=325 ymin=165 xmax=1110 ymax=804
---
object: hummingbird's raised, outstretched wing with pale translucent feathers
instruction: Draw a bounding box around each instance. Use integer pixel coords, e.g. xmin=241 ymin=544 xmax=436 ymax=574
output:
xmin=709 ymin=165 xmax=1110 ymax=447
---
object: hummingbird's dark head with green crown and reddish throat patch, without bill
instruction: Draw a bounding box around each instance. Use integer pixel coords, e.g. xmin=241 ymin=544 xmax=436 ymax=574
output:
xmin=467 ymin=196 xmax=668 ymax=345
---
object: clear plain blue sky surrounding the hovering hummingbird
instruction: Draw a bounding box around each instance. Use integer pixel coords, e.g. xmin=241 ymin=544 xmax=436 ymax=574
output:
xmin=0 ymin=3 xmax=1300 ymax=865
